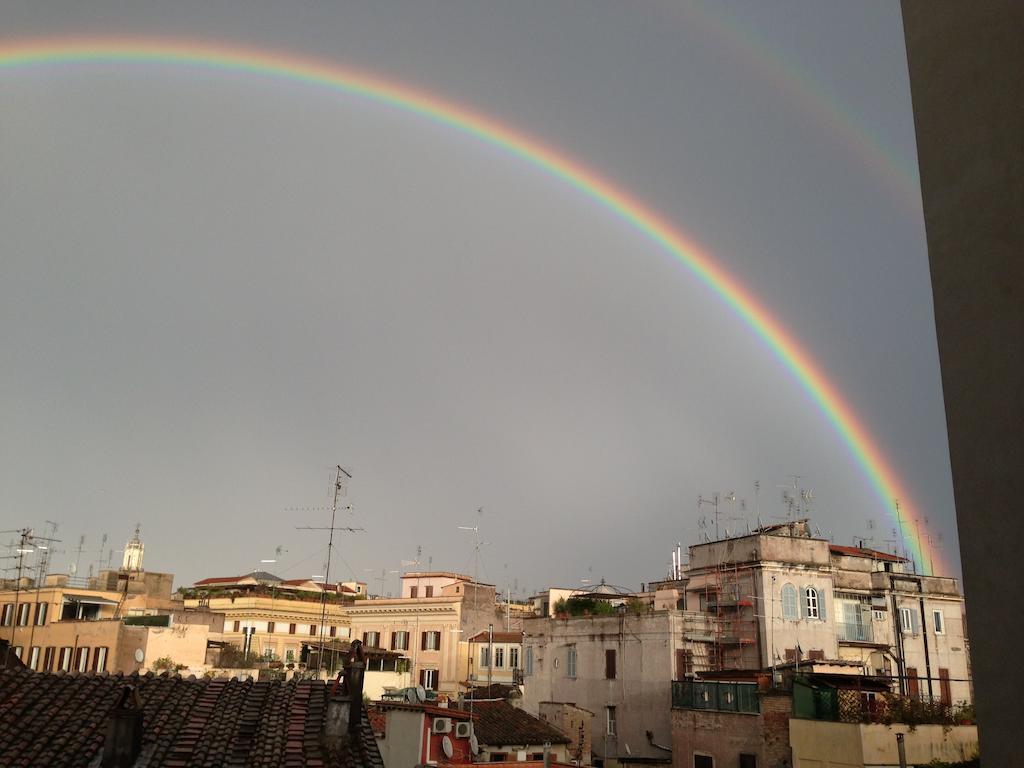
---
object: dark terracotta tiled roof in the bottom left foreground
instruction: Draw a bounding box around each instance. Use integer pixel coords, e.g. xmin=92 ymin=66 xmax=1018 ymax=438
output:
xmin=0 ymin=670 xmax=383 ymax=768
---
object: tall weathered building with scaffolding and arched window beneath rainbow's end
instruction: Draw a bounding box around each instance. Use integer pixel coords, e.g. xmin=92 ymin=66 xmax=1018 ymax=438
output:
xmin=685 ymin=520 xmax=972 ymax=705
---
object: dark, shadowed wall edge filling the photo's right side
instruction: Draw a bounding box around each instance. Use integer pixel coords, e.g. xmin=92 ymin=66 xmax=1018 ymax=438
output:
xmin=902 ymin=0 xmax=1024 ymax=765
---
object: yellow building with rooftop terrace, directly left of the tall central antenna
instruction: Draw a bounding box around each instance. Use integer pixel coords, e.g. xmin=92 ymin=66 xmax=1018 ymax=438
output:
xmin=182 ymin=571 xmax=356 ymax=665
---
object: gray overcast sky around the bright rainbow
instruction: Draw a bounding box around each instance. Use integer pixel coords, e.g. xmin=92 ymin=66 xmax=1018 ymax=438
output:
xmin=0 ymin=0 xmax=958 ymax=593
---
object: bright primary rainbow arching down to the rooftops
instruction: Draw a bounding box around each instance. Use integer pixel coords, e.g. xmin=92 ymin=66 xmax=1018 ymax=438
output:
xmin=0 ymin=38 xmax=950 ymax=572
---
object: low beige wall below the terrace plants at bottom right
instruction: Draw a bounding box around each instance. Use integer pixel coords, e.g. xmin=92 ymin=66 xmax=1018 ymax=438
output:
xmin=790 ymin=719 xmax=978 ymax=768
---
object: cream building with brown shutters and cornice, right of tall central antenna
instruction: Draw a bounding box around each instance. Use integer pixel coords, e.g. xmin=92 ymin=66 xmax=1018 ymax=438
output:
xmin=344 ymin=571 xmax=504 ymax=697
